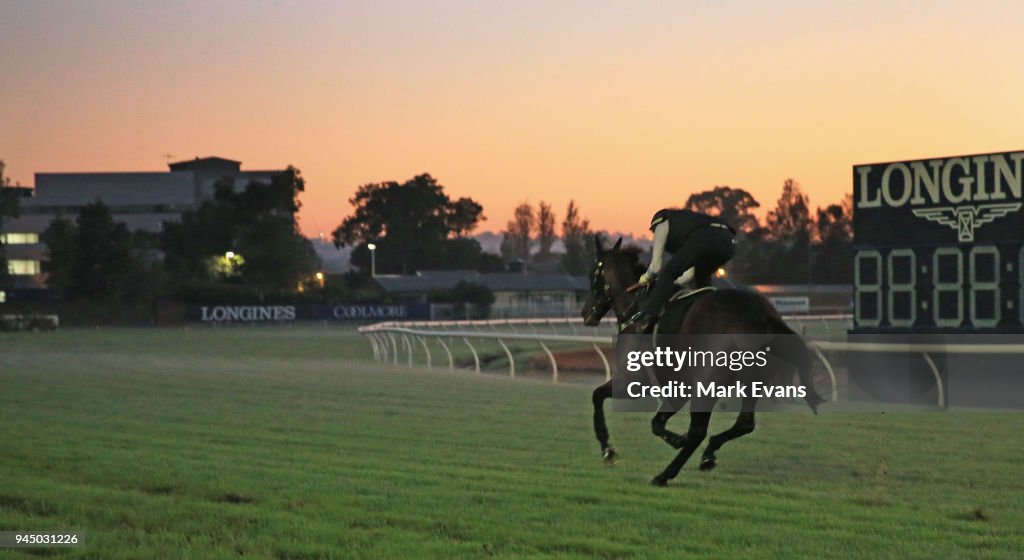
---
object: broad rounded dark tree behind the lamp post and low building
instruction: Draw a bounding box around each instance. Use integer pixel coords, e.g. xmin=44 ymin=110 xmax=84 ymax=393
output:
xmin=332 ymin=173 xmax=486 ymax=274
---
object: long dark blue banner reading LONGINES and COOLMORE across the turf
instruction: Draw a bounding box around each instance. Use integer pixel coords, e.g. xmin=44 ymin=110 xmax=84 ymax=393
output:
xmin=188 ymin=303 xmax=430 ymax=322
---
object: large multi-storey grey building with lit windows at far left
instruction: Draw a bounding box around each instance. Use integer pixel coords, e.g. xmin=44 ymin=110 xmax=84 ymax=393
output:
xmin=0 ymin=158 xmax=283 ymax=289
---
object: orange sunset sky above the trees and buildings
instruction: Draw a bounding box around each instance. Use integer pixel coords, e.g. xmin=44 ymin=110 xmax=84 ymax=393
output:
xmin=0 ymin=0 xmax=1024 ymax=235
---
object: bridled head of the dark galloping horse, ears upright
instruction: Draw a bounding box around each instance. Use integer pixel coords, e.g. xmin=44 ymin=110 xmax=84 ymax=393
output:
xmin=582 ymin=235 xmax=637 ymax=327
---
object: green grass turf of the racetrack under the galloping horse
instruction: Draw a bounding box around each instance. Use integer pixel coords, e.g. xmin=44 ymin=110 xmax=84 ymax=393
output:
xmin=0 ymin=328 xmax=1024 ymax=559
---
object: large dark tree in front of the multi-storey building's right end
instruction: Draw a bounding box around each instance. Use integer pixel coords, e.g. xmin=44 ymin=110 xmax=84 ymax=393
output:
xmin=160 ymin=167 xmax=317 ymax=298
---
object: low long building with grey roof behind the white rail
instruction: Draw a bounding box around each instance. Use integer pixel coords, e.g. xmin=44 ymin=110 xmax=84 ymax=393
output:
xmin=374 ymin=270 xmax=590 ymax=318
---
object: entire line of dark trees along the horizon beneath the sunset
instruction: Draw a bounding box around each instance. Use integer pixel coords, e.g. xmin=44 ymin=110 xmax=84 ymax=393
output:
xmin=0 ymin=163 xmax=853 ymax=301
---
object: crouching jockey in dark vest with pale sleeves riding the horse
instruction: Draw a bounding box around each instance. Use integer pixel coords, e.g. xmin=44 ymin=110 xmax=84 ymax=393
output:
xmin=622 ymin=209 xmax=736 ymax=333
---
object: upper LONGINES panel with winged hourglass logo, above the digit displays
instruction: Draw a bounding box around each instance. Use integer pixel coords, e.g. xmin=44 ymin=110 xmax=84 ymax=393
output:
xmin=853 ymin=152 xmax=1024 ymax=246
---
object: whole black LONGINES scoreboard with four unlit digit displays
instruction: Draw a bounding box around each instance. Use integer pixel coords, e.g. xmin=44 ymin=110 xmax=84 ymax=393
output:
xmin=852 ymin=152 xmax=1024 ymax=334
